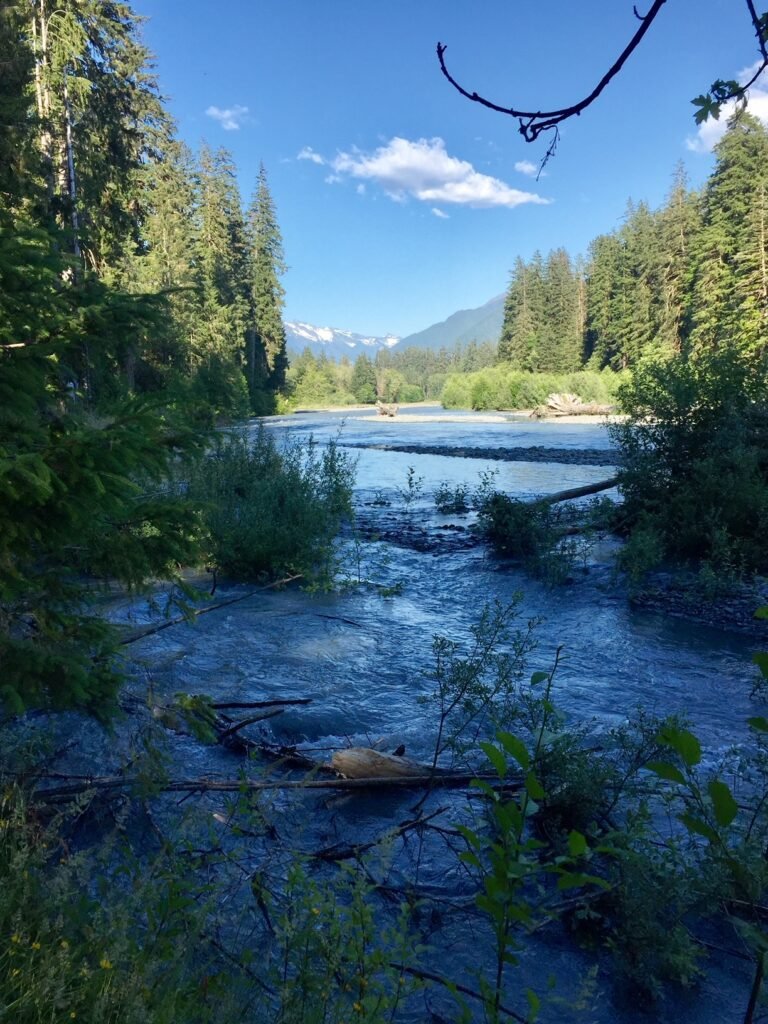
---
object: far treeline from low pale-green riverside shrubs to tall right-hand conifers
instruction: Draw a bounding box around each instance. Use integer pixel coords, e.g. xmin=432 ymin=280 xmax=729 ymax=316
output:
xmin=289 ymin=113 xmax=768 ymax=409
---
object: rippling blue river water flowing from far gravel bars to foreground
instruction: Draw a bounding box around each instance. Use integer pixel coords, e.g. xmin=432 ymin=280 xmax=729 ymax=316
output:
xmin=66 ymin=409 xmax=764 ymax=1024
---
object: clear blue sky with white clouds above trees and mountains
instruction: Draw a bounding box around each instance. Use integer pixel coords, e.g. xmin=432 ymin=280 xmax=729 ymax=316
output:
xmin=134 ymin=0 xmax=768 ymax=336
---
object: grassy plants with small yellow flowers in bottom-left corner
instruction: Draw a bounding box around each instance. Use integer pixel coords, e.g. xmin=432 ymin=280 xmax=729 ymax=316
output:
xmin=0 ymin=783 xmax=238 ymax=1024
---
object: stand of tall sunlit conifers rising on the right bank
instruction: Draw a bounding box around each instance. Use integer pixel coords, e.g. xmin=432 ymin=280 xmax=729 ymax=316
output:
xmin=499 ymin=113 xmax=768 ymax=373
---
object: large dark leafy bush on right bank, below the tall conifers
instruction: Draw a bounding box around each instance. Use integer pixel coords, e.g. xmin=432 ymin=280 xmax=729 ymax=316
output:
xmin=611 ymin=351 xmax=768 ymax=570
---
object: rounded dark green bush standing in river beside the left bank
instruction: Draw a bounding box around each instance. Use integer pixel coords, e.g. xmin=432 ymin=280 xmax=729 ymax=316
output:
xmin=188 ymin=426 xmax=354 ymax=580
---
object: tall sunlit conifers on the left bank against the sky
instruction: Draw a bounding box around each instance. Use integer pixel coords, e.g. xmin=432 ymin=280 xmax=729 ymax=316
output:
xmin=0 ymin=0 xmax=287 ymax=418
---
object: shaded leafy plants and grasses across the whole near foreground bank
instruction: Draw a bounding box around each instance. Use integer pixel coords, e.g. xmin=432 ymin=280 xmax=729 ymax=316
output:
xmin=0 ymin=605 xmax=768 ymax=1024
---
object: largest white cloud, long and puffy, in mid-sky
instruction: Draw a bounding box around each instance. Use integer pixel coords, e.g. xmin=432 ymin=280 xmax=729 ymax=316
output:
xmin=332 ymin=137 xmax=550 ymax=208
